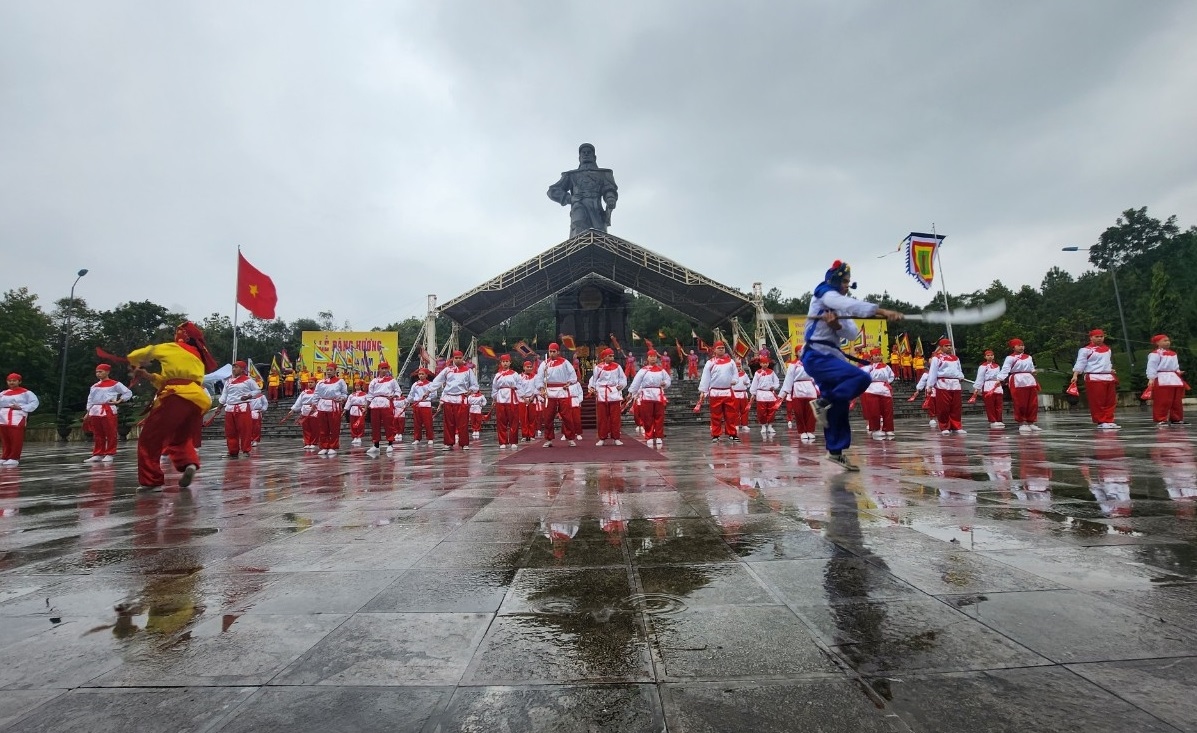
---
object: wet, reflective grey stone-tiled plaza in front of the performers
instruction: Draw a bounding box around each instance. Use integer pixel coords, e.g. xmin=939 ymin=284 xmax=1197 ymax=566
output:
xmin=0 ymin=411 xmax=1197 ymax=733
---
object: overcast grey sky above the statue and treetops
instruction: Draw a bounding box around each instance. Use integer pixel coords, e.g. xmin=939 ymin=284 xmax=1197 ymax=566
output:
xmin=0 ymin=0 xmax=1197 ymax=329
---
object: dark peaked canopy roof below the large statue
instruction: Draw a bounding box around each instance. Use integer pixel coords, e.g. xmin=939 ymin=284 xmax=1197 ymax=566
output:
xmin=440 ymin=229 xmax=753 ymax=334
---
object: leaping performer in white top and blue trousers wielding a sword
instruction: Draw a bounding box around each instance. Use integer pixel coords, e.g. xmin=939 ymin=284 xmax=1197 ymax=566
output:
xmin=802 ymin=260 xmax=903 ymax=471
